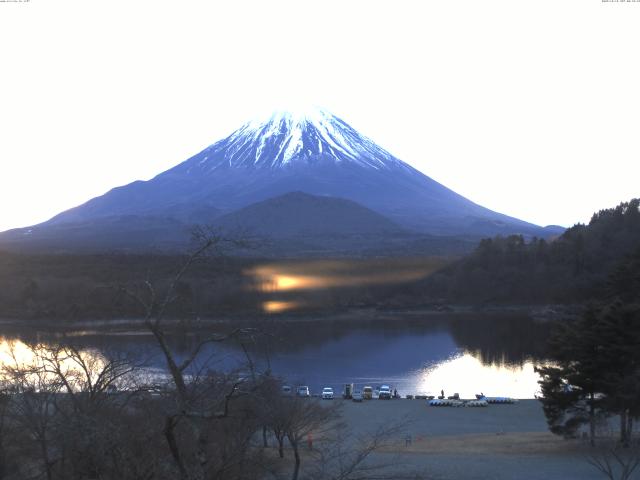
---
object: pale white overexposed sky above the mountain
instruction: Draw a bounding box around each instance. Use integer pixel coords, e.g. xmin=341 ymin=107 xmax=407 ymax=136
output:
xmin=0 ymin=0 xmax=640 ymax=231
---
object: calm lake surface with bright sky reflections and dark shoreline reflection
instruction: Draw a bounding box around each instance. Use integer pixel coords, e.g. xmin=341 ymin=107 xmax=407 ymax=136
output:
xmin=0 ymin=315 xmax=549 ymax=398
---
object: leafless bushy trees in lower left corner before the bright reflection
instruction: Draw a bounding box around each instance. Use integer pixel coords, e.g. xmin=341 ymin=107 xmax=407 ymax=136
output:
xmin=3 ymin=345 xmax=162 ymax=480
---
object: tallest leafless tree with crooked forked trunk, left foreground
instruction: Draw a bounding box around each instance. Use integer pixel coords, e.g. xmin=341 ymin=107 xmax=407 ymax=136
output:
xmin=120 ymin=228 xmax=268 ymax=480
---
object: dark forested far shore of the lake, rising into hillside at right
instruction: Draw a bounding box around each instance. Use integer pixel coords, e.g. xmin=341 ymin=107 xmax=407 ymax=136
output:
xmin=0 ymin=199 xmax=640 ymax=322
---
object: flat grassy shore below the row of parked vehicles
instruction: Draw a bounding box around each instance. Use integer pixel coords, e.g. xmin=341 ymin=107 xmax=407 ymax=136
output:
xmin=328 ymin=400 xmax=603 ymax=480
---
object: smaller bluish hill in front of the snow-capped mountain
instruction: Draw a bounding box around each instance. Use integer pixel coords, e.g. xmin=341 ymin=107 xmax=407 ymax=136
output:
xmin=213 ymin=192 xmax=475 ymax=258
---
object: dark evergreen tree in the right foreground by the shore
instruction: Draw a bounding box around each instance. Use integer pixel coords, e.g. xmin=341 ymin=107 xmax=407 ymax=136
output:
xmin=537 ymin=246 xmax=640 ymax=478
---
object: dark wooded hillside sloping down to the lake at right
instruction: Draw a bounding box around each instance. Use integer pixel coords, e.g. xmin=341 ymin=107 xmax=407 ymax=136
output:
xmin=412 ymin=199 xmax=640 ymax=304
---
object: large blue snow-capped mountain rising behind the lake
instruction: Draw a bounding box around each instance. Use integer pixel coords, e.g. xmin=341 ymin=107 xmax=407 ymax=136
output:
xmin=0 ymin=110 xmax=562 ymax=253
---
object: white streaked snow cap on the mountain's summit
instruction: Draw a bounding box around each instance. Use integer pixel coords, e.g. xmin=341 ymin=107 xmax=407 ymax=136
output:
xmin=192 ymin=109 xmax=405 ymax=170
